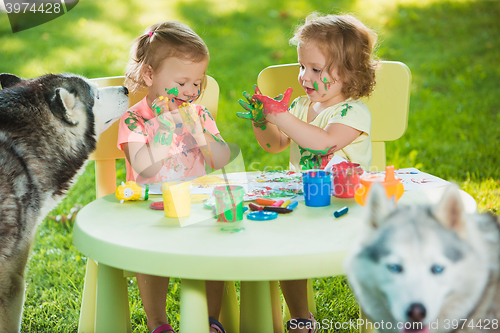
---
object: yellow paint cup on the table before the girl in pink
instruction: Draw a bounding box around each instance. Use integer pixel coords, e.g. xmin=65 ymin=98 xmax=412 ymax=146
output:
xmin=161 ymin=181 xmax=191 ymax=217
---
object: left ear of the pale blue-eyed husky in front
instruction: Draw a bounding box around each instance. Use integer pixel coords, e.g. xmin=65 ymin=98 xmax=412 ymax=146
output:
xmin=366 ymin=182 xmax=396 ymax=228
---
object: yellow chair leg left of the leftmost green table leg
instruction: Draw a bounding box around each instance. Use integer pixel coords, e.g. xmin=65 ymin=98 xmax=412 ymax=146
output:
xmin=78 ymin=258 xmax=97 ymax=333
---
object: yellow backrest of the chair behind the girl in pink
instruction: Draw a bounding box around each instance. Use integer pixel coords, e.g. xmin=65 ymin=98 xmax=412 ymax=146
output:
xmin=90 ymin=76 xmax=219 ymax=198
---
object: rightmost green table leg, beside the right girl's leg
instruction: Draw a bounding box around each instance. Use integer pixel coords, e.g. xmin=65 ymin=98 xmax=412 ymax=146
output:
xmin=240 ymin=281 xmax=273 ymax=333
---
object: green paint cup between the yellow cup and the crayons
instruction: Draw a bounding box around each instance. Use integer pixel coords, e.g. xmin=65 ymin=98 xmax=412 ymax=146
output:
xmin=214 ymin=185 xmax=245 ymax=231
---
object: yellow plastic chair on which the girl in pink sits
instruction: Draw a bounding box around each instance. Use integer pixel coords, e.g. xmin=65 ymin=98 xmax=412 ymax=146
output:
xmin=78 ymin=76 xmax=239 ymax=333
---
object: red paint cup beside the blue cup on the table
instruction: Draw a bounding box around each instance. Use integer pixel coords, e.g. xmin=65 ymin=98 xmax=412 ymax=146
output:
xmin=332 ymin=162 xmax=363 ymax=198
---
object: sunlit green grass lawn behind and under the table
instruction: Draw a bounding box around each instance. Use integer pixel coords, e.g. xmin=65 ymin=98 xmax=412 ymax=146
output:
xmin=0 ymin=0 xmax=500 ymax=333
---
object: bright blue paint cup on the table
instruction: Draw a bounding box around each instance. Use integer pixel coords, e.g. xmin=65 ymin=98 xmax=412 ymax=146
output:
xmin=302 ymin=170 xmax=332 ymax=207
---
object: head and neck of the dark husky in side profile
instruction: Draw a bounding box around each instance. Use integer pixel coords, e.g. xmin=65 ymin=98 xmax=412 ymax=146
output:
xmin=0 ymin=74 xmax=128 ymax=200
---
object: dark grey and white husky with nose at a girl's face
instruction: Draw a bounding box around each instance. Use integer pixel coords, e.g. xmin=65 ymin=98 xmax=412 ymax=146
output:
xmin=0 ymin=74 xmax=128 ymax=333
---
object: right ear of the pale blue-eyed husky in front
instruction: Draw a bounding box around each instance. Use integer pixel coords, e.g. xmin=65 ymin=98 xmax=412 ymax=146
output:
xmin=434 ymin=185 xmax=466 ymax=239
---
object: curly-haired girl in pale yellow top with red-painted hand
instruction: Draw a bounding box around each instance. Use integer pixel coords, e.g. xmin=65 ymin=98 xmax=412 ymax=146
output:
xmin=240 ymin=15 xmax=376 ymax=332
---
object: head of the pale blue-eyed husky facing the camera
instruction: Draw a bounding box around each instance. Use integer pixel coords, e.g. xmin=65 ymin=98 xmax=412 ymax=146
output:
xmin=346 ymin=184 xmax=498 ymax=332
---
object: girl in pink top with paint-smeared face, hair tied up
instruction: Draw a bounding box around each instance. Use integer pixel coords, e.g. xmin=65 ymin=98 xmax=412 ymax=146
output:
xmin=118 ymin=22 xmax=230 ymax=333
